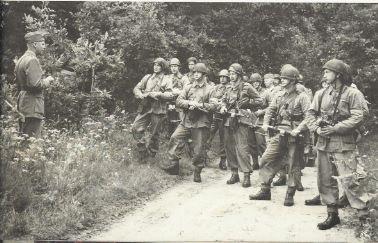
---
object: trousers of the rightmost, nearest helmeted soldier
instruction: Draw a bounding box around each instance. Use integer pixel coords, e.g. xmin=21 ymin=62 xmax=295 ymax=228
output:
xmin=317 ymin=150 xmax=366 ymax=212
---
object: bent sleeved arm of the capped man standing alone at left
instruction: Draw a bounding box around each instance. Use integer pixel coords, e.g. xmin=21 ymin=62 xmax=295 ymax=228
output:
xmin=25 ymin=58 xmax=49 ymax=92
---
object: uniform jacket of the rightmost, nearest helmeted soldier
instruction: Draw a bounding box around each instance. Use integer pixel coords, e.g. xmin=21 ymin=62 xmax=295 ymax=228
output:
xmin=306 ymin=85 xmax=368 ymax=152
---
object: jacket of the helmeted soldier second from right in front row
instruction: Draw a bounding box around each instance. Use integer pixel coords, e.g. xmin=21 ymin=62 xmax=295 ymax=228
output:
xmin=264 ymin=87 xmax=311 ymax=131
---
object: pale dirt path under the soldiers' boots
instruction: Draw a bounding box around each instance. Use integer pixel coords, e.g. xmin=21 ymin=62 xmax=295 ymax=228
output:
xmin=90 ymin=168 xmax=359 ymax=242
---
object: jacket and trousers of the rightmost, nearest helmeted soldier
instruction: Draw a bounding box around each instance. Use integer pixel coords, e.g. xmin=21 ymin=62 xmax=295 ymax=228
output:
xmin=307 ymin=85 xmax=367 ymax=212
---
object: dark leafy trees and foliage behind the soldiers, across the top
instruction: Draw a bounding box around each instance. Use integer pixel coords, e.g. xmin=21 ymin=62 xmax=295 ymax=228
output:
xmin=2 ymin=2 xmax=378 ymax=123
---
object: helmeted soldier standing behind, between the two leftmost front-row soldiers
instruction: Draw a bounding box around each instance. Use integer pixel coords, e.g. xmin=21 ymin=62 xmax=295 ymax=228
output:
xmin=165 ymin=58 xmax=184 ymax=137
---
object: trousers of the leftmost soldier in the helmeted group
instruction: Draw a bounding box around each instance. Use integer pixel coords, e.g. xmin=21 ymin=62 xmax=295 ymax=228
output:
xmin=132 ymin=113 xmax=165 ymax=153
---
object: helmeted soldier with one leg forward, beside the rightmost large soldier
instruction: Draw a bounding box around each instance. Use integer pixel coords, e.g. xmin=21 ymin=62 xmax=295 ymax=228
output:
xmin=249 ymin=64 xmax=310 ymax=206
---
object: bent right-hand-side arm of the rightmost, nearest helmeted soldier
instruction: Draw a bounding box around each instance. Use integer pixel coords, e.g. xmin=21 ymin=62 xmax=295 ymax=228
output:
xmin=334 ymin=90 xmax=365 ymax=134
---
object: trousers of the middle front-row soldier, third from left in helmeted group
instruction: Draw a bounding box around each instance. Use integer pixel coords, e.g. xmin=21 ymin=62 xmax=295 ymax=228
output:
xmin=224 ymin=124 xmax=253 ymax=173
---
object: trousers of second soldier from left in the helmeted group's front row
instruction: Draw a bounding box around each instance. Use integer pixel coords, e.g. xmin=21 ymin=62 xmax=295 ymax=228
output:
xmin=168 ymin=124 xmax=209 ymax=168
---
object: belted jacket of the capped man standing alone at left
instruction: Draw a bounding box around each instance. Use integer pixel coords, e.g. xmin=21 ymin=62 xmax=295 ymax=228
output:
xmin=14 ymin=50 xmax=46 ymax=119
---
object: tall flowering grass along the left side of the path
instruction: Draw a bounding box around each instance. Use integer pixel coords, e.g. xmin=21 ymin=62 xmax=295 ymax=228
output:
xmin=0 ymin=116 xmax=199 ymax=239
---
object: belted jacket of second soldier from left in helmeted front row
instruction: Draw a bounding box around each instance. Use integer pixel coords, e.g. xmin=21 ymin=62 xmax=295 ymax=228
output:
xmin=176 ymin=81 xmax=216 ymax=128
